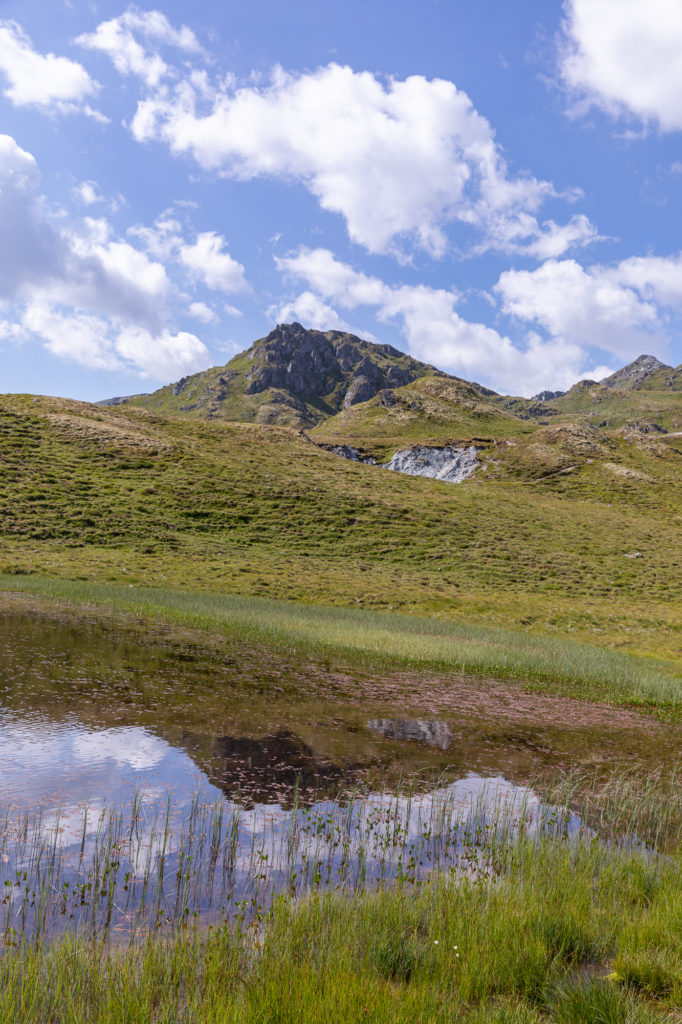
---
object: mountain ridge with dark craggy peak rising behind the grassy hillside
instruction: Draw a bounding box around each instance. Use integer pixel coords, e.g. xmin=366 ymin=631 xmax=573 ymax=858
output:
xmin=116 ymin=323 xmax=682 ymax=456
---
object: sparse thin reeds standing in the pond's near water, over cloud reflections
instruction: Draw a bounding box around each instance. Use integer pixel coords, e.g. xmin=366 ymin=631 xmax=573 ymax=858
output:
xmin=0 ymin=779 xmax=561 ymax=946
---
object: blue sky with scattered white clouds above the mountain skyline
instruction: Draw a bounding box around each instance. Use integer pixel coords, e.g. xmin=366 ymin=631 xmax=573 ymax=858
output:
xmin=0 ymin=0 xmax=682 ymax=401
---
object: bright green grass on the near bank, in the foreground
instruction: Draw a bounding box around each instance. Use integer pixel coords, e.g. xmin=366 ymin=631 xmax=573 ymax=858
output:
xmin=0 ymin=778 xmax=682 ymax=1024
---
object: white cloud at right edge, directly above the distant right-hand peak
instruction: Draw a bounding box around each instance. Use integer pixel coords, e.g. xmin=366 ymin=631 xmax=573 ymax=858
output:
xmin=495 ymin=256 xmax=682 ymax=357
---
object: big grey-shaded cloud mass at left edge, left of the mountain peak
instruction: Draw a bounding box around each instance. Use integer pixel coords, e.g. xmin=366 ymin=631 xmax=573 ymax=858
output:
xmin=0 ymin=135 xmax=211 ymax=380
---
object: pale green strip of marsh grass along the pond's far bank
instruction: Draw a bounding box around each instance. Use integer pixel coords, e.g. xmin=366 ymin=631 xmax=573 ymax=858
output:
xmin=0 ymin=575 xmax=682 ymax=711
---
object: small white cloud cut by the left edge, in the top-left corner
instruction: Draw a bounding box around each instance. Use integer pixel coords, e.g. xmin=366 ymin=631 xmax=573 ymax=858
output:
xmin=0 ymin=22 xmax=102 ymax=120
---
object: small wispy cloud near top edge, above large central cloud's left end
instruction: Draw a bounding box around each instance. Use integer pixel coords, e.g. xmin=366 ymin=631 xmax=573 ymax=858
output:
xmin=76 ymin=7 xmax=201 ymax=86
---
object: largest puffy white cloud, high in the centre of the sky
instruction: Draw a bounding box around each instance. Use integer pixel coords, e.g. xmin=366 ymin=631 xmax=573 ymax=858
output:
xmin=131 ymin=65 xmax=594 ymax=256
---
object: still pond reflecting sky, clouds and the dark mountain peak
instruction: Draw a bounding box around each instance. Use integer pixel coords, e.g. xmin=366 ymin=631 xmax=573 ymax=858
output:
xmin=0 ymin=599 xmax=679 ymax=944
